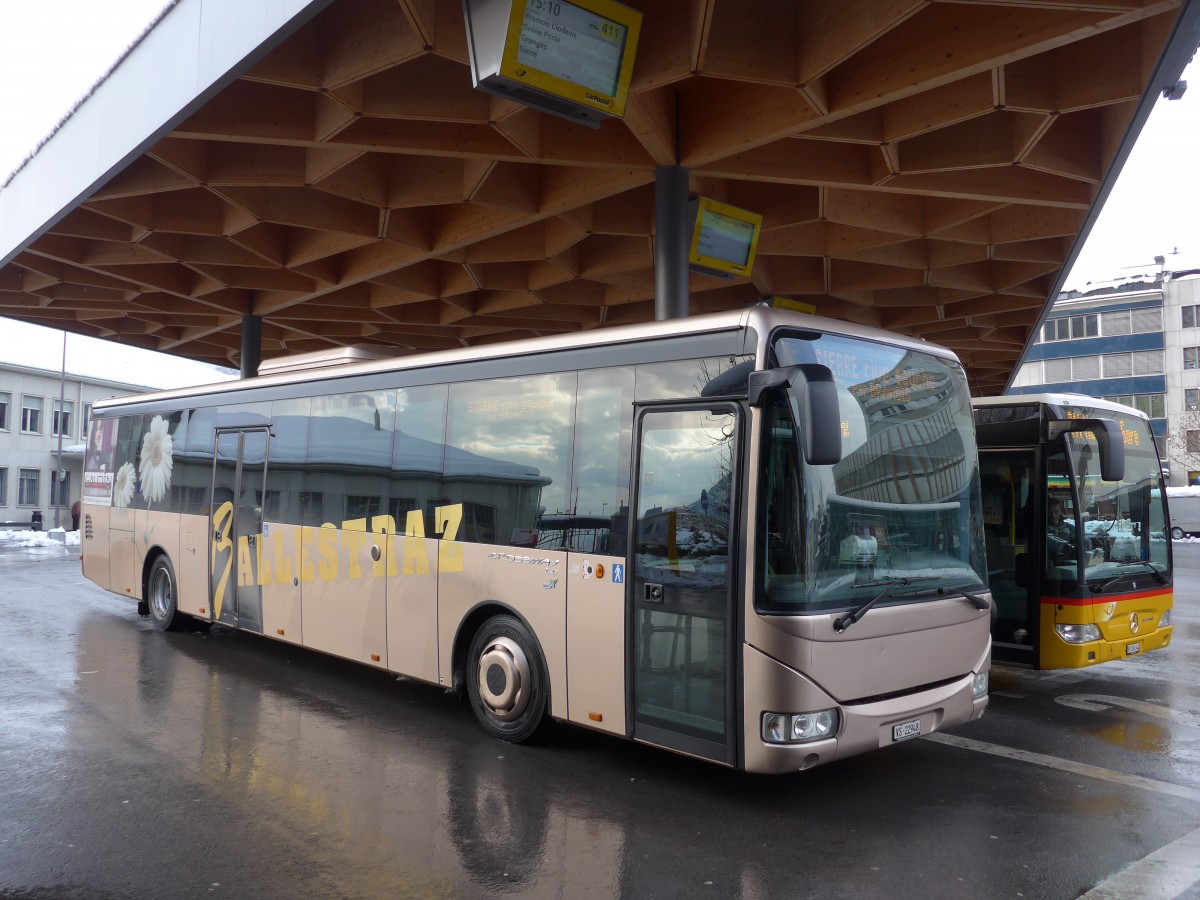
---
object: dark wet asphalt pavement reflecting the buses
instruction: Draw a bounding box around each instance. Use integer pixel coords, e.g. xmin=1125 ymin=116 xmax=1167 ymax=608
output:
xmin=0 ymin=544 xmax=1200 ymax=900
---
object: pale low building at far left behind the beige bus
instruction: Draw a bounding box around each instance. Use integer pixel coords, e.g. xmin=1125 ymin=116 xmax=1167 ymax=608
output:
xmin=0 ymin=362 xmax=150 ymax=530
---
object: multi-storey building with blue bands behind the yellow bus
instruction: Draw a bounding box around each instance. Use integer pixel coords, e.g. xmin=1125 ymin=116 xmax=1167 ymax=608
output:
xmin=1009 ymin=271 xmax=1200 ymax=485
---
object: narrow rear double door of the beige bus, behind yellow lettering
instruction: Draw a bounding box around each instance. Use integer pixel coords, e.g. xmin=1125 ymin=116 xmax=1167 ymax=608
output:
xmin=209 ymin=428 xmax=268 ymax=632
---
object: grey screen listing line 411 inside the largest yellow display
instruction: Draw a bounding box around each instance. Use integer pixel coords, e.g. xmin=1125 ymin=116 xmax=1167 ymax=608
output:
xmin=514 ymin=0 xmax=629 ymax=99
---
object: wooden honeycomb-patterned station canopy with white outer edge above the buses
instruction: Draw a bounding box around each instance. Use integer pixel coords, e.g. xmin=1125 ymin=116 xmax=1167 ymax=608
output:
xmin=0 ymin=0 xmax=1198 ymax=394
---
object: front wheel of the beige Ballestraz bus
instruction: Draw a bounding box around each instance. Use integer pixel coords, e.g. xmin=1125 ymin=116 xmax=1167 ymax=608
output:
xmin=467 ymin=616 xmax=547 ymax=744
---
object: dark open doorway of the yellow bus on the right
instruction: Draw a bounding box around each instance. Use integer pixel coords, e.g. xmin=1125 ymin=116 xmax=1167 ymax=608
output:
xmin=979 ymin=450 xmax=1042 ymax=666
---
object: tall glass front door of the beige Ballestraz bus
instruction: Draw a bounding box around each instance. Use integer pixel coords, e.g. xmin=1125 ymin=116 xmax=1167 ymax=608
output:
xmin=626 ymin=403 xmax=739 ymax=763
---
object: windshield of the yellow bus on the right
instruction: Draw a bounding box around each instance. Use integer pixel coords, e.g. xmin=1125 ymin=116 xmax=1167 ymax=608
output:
xmin=1046 ymin=407 xmax=1168 ymax=593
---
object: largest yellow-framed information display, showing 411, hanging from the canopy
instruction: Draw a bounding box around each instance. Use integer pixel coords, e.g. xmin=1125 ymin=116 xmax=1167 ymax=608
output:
xmin=464 ymin=0 xmax=642 ymax=126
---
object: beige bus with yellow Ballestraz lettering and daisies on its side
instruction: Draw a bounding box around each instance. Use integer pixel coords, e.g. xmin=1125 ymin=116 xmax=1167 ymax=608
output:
xmin=82 ymin=307 xmax=991 ymax=773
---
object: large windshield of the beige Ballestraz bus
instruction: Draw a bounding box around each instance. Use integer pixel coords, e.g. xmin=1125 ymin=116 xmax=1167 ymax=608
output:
xmin=756 ymin=334 xmax=986 ymax=614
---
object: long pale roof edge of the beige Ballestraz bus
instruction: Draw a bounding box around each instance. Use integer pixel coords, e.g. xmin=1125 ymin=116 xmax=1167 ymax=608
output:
xmin=94 ymin=306 xmax=958 ymax=410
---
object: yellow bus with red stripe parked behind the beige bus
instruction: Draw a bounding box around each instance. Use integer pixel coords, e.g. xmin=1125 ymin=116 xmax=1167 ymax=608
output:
xmin=974 ymin=394 xmax=1172 ymax=668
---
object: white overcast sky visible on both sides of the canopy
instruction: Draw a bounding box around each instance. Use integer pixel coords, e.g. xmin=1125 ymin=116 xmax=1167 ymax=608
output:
xmin=0 ymin=0 xmax=1200 ymax=386
